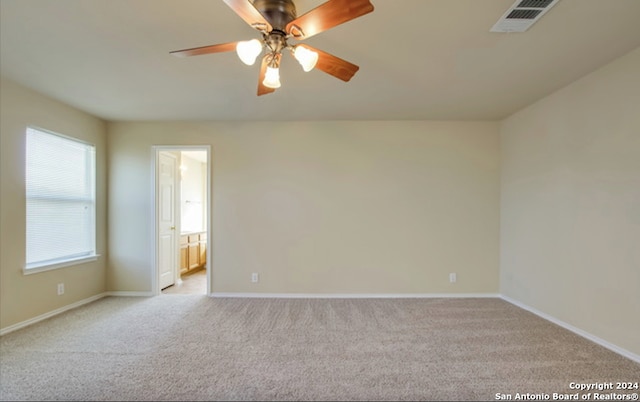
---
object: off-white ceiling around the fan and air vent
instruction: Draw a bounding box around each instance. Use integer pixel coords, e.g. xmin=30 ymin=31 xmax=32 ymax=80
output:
xmin=0 ymin=0 xmax=640 ymax=121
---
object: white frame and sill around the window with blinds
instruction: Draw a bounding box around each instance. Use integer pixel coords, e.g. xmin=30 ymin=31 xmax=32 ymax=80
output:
xmin=22 ymin=125 xmax=100 ymax=275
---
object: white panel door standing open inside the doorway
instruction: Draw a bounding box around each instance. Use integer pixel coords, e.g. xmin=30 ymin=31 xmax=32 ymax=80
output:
xmin=157 ymin=152 xmax=178 ymax=289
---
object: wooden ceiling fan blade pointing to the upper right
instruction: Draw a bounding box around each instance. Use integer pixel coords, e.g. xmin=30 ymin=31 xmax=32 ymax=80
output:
xmin=286 ymin=0 xmax=373 ymax=39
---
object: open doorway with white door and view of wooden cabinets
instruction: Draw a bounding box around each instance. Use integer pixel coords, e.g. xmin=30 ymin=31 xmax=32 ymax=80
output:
xmin=152 ymin=146 xmax=212 ymax=295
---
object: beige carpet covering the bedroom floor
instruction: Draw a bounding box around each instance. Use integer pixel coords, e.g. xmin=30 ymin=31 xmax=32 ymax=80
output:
xmin=0 ymin=295 xmax=640 ymax=401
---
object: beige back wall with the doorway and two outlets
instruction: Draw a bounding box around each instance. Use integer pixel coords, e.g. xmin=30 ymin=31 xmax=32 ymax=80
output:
xmin=108 ymin=122 xmax=499 ymax=294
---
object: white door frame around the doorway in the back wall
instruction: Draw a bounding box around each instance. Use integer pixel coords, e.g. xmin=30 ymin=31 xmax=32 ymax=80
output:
xmin=150 ymin=145 xmax=213 ymax=296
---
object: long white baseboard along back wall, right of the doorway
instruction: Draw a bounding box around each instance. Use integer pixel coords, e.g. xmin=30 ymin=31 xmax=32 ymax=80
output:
xmin=209 ymin=292 xmax=500 ymax=299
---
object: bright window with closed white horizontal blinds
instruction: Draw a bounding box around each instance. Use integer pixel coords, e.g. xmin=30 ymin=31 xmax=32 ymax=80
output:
xmin=25 ymin=128 xmax=96 ymax=273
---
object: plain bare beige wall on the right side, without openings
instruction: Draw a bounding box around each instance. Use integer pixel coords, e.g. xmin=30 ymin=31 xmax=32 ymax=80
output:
xmin=500 ymin=49 xmax=640 ymax=354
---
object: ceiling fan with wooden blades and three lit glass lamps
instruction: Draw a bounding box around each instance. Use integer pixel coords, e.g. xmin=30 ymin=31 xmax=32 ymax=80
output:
xmin=170 ymin=0 xmax=373 ymax=96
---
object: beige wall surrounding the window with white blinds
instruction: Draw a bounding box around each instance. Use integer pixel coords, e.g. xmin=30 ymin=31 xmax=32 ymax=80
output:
xmin=0 ymin=79 xmax=107 ymax=329
